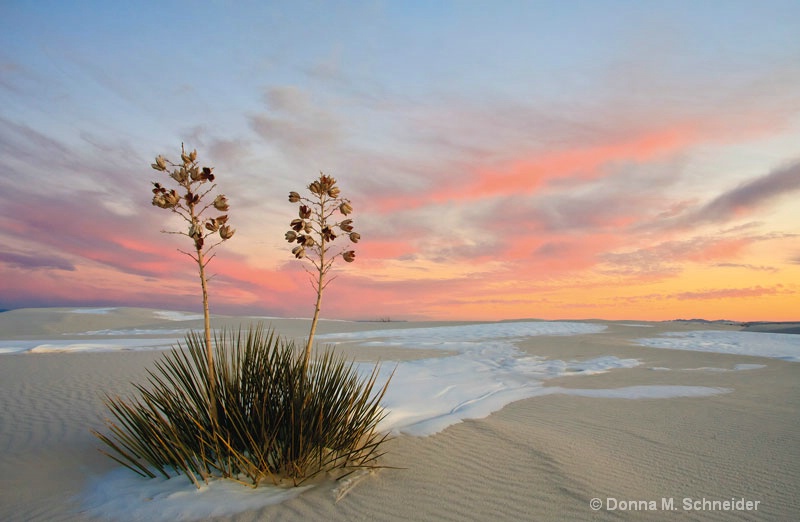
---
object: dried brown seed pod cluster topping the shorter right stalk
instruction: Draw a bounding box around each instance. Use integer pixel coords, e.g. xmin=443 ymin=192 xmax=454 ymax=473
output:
xmin=285 ymin=174 xmax=361 ymax=262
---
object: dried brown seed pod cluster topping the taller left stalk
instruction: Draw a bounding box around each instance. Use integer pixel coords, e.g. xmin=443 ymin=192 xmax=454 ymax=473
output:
xmin=150 ymin=149 xmax=235 ymax=251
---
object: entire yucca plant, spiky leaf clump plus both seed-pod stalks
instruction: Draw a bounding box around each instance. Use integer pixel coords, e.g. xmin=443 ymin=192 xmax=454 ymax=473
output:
xmin=92 ymin=159 xmax=388 ymax=487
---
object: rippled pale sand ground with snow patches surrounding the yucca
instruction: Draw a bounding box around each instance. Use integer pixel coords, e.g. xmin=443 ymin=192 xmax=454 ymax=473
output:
xmin=0 ymin=309 xmax=800 ymax=520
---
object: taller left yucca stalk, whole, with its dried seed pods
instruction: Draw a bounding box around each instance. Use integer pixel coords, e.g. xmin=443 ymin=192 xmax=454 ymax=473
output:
xmin=150 ymin=144 xmax=235 ymax=424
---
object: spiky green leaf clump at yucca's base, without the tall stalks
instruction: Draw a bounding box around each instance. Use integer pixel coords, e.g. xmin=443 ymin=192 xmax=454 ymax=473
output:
xmin=93 ymin=325 xmax=388 ymax=487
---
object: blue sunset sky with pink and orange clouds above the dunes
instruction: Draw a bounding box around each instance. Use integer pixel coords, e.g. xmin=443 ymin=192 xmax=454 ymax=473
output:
xmin=0 ymin=0 xmax=800 ymax=321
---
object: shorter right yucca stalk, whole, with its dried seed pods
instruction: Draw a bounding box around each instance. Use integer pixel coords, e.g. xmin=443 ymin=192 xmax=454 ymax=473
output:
xmin=286 ymin=172 xmax=361 ymax=368
